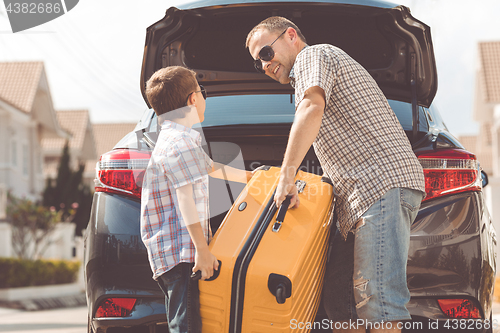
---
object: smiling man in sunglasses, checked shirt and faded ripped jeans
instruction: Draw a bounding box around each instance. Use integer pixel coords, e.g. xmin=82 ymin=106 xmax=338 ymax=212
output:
xmin=246 ymin=17 xmax=425 ymax=332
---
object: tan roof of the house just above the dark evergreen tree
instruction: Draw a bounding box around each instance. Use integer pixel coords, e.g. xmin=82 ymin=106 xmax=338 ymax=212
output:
xmin=42 ymin=110 xmax=90 ymax=152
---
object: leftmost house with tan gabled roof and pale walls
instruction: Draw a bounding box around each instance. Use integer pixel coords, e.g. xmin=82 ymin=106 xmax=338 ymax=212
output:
xmin=0 ymin=62 xmax=70 ymax=202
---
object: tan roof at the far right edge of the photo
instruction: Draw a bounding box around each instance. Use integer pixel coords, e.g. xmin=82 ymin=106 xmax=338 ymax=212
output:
xmin=479 ymin=41 xmax=500 ymax=103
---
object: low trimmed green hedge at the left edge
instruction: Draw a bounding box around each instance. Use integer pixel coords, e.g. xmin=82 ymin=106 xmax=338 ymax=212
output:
xmin=0 ymin=258 xmax=80 ymax=288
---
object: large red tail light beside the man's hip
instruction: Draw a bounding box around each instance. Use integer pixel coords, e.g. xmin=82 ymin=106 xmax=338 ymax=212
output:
xmin=417 ymin=149 xmax=481 ymax=200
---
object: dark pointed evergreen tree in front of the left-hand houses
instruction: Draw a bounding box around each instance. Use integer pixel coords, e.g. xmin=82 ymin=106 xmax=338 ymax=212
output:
xmin=43 ymin=141 xmax=92 ymax=235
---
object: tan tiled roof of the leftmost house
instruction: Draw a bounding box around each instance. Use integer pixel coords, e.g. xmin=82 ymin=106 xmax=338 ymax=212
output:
xmin=0 ymin=61 xmax=44 ymax=113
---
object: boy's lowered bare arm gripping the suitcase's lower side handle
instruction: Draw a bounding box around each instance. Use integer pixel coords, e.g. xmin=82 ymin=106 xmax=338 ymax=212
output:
xmin=175 ymin=184 xmax=219 ymax=280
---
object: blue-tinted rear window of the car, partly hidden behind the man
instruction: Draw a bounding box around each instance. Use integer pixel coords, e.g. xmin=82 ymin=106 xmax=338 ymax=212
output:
xmin=197 ymin=94 xmax=428 ymax=131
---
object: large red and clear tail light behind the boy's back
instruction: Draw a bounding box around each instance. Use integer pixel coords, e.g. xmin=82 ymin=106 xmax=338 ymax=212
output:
xmin=95 ymin=149 xmax=151 ymax=198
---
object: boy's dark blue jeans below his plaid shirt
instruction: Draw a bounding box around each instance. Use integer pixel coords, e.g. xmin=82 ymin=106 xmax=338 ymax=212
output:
xmin=157 ymin=263 xmax=201 ymax=333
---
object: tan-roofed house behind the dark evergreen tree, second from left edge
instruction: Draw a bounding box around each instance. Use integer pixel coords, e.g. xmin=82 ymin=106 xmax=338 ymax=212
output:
xmin=42 ymin=110 xmax=97 ymax=188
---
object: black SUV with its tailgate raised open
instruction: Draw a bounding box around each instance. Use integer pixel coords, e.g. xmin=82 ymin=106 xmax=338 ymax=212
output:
xmin=85 ymin=0 xmax=496 ymax=333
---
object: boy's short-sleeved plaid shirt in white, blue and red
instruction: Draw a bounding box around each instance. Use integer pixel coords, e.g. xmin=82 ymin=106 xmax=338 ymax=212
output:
xmin=141 ymin=120 xmax=212 ymax=280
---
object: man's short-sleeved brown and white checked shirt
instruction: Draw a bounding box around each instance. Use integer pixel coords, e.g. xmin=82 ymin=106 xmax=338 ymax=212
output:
xmin=290 ymin=44 xmax=425 ymax=238
